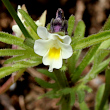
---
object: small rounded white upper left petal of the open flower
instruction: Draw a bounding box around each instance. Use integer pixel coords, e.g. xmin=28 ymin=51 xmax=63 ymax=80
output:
xmin=37 ymin=26 xmax=49 ymax=40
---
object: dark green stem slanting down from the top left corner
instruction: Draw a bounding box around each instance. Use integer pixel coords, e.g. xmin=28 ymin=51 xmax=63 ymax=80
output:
xmin=2 ymin=0 xmax=31 ymax=38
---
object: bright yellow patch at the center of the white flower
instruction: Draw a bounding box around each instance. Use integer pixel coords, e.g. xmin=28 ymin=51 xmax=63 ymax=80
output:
xmin=49 ymin=47 xmax=61 ymax=60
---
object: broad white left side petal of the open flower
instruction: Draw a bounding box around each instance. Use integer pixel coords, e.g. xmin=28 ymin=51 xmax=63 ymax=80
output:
xmin=34 ymin=39 xmax=52 ymax=56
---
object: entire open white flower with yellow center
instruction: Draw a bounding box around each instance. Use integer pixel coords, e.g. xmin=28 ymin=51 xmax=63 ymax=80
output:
xmin=34 ymin=27 xmax=73 ymax=72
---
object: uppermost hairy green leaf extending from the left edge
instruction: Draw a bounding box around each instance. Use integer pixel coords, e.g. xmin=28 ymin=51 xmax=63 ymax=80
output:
xmin=0 ymin=32 xmax=31 ymax=49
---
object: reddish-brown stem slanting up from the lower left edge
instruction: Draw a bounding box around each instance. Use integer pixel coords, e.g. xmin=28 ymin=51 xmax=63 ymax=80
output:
xmin=0 ymin=69 xmax=26 ymax=95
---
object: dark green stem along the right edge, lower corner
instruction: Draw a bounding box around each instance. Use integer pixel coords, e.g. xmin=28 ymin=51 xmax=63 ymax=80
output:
xmin=98 ymin=66 xmax=110 ymax=110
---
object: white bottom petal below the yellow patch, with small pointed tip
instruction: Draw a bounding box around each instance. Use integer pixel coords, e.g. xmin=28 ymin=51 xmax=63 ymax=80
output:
xmin=43 ymin=51 xmax=62 ymax=72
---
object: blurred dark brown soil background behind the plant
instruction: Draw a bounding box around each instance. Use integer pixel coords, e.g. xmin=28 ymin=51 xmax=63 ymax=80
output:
xmin=0 ymin=0 xmax=110 ymax=110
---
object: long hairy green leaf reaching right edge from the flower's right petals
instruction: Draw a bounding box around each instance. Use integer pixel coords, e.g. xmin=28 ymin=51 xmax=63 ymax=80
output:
xmin=72 ymin=31 xmax=110 ymax=50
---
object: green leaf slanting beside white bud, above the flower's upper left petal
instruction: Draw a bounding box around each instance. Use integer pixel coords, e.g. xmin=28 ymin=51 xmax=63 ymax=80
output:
xmin=19 ymin=9 xmax=38 ymax=32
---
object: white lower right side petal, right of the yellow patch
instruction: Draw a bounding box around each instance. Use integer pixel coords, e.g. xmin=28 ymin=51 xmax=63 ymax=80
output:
xmin=59 ymin=42 xmax=73 ymax=59
